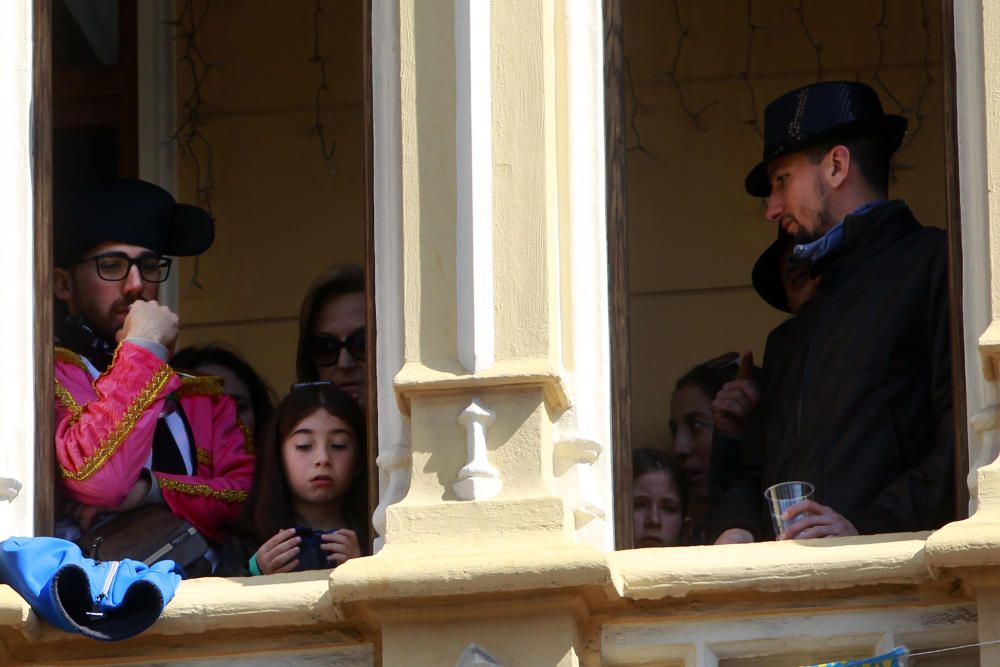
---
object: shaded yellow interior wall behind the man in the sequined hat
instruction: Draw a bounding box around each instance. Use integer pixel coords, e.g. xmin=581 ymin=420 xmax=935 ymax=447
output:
xmin=625 ymin=0 xmax=945 ymax=446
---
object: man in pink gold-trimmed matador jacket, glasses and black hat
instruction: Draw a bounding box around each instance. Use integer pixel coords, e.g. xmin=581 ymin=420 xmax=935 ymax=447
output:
xmin=53 ymin=180 xmax=253 ymax=552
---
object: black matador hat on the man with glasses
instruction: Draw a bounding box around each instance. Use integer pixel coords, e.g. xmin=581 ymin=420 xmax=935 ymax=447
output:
xmin=53 ymin=179 xmax=215 ymax=267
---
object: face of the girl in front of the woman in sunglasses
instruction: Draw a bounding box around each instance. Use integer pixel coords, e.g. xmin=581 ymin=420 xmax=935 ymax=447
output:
xmin=281 ymin=408 xmax=358 ymax=505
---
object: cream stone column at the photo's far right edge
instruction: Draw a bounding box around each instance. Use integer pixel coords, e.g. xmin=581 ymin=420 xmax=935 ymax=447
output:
xmin=926 ymin=2 xmax=1000 ymax=665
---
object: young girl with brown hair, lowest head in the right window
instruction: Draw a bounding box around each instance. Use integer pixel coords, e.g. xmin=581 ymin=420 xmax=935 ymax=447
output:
xmin=632 ymin=448 xmax=688 ymax=549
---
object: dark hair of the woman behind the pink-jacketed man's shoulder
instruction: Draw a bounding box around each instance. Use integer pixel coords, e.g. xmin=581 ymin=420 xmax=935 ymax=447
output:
xmin=170 ymin=344 xmax=274 ymax=451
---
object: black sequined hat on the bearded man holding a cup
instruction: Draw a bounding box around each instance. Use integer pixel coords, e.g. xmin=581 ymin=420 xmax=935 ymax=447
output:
xmin=745 ymin=81 xmax=906 ymax=197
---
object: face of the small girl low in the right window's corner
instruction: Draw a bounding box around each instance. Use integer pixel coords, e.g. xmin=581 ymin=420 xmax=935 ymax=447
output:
xmin=632 ymin=470 xmax=684 ymax=548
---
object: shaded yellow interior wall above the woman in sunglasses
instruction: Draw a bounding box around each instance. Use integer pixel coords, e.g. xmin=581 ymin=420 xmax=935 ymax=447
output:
xmin=178 ymin=0 xmax=365 ymax=394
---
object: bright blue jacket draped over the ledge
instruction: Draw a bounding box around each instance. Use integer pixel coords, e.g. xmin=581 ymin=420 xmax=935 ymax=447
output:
xmin=0 ymin=537 xmax=182 ymax=641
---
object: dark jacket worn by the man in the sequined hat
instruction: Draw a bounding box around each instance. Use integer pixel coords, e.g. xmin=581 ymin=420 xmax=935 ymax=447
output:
xmin=709 ymin=201 xmax=954 ymax=540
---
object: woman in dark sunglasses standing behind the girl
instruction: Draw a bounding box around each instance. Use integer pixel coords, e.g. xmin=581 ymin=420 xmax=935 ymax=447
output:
xmin=296 ymin=264 xmax=367 ymax=409
